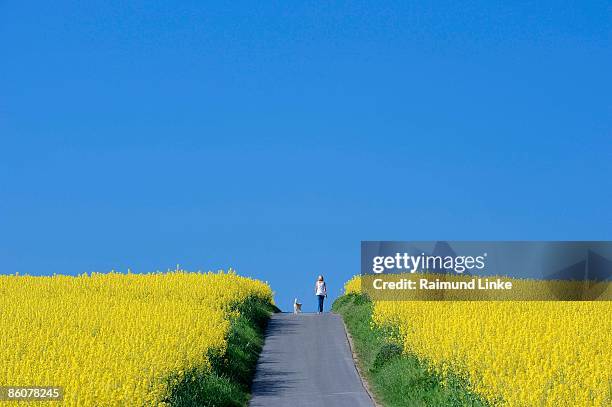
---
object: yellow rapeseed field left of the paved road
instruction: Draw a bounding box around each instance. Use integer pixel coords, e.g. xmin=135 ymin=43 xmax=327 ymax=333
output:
xmin=0 ymin=270 xmax=272 ymax=406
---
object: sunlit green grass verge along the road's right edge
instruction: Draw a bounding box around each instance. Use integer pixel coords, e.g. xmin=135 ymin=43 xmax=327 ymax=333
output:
xmin=332 ymin=294 xmax=488 ymax=407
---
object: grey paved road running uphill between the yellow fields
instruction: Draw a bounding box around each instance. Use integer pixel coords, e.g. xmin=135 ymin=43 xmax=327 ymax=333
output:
xmin=250 ymin=313 xmax=373 ymax=407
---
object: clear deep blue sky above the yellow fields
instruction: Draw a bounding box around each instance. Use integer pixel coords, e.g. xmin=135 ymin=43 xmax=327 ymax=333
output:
xmin=0 ymin=1 xmax=612 ymax=310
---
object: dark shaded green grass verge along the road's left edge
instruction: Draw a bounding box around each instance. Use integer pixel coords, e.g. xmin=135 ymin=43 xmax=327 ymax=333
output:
xmin=166 ymin=298 xmax=278 ymax=407
